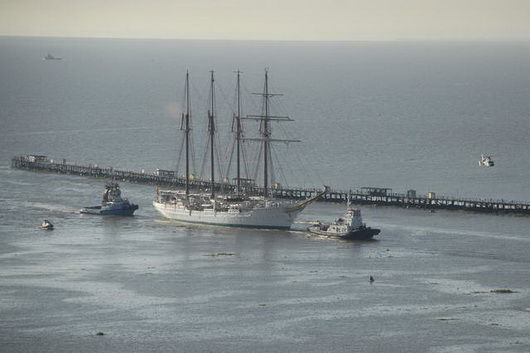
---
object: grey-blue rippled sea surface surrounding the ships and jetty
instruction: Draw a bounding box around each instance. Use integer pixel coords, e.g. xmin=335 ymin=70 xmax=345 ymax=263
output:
xmin=0 ymin=37 xmax=530 ymax=353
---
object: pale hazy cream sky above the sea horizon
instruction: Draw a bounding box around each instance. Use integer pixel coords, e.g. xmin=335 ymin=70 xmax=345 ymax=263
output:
xmin=0 ymin=0 xmax=530 ymax=40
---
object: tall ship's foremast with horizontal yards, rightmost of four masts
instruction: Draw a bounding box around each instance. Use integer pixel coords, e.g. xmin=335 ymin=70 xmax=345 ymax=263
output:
xmin=243 ymin=69 xmax=300 ymax=198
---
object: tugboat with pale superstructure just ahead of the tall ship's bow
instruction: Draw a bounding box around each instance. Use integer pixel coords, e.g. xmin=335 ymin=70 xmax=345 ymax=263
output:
xmin=307 ymin=204 xmax=381 ymax=240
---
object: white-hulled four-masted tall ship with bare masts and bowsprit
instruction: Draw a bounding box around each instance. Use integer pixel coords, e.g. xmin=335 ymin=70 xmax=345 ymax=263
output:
xmin=153 ymin=71 xmax=320 ymax=229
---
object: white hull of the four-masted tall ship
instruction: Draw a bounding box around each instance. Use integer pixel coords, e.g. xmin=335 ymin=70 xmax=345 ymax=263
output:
xmin=153 ymin=201 xmax=299 ymax=229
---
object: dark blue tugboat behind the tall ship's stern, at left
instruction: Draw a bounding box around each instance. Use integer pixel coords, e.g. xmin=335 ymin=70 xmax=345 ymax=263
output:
xmin=79 ymin=182 xmax=138 ymax=216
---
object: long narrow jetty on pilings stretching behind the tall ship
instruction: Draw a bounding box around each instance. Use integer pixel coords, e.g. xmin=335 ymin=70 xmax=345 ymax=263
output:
xmin=11 ymin=155 xmax=530 ymax=215
